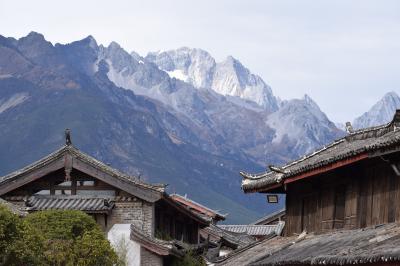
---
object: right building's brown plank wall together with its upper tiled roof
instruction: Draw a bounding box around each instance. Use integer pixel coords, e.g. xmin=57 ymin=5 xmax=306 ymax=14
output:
xmin=242 ymin=111 xmax=400 ymax=236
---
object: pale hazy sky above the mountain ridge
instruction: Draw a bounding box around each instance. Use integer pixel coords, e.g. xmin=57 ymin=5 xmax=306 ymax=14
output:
xmin=0 ymin=0 xmax=400 ymax=122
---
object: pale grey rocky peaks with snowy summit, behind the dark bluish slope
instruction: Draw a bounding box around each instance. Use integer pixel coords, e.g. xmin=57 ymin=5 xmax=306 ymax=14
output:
xmin=96 ymin=43 xmax=340 ymax=163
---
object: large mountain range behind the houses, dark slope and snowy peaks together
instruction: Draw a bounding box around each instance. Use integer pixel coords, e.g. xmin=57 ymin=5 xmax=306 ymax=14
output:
xmin=0 ymin=32 xmax=342 ymax=223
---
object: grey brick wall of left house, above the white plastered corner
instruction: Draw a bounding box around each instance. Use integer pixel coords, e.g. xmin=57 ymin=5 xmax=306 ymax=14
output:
xmin=107 ymin=197 xmax=154 ymax=236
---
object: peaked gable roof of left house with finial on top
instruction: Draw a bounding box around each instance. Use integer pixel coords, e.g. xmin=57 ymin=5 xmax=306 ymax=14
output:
xmin=0 ymin=145 xmax=165 ymax=202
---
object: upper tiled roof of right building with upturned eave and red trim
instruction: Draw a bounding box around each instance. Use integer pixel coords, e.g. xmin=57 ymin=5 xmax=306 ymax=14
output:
xmin=240 ymin=110 xmax=400 ymax=192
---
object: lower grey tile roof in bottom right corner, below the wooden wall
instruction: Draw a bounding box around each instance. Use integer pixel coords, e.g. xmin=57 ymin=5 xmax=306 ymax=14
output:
xmin=215 ymin=223 xmax=400 ymax=266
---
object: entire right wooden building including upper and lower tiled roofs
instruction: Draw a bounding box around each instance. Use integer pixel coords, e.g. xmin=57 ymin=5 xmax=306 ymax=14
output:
xmin=231 ymin=110 xmax=400 ymax=266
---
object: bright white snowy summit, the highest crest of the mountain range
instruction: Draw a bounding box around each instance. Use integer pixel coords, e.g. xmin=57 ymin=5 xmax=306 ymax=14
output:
xmin=146 ymin=47 xmax=278 ymax=112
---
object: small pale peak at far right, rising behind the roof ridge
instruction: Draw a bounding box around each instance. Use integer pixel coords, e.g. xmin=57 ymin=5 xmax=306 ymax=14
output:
xmin=353 ymin=92 xmax=400 ymax=129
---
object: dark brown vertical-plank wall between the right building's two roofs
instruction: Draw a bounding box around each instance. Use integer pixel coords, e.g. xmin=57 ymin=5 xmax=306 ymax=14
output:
xmin=286 ymin=159 xmax=400 ymax=235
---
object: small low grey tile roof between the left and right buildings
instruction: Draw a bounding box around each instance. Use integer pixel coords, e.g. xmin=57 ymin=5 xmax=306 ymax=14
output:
xmin=218 ymin=221 xmax=285 ymax=236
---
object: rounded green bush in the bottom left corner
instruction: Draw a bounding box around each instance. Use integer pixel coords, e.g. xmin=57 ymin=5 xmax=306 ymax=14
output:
xmin=0 ymin=206 xmax=119 ymax=266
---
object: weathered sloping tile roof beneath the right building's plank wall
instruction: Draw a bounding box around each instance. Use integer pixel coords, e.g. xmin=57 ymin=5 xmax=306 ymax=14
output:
xmin=250 ymin=224 xmax=400 ymax=265
